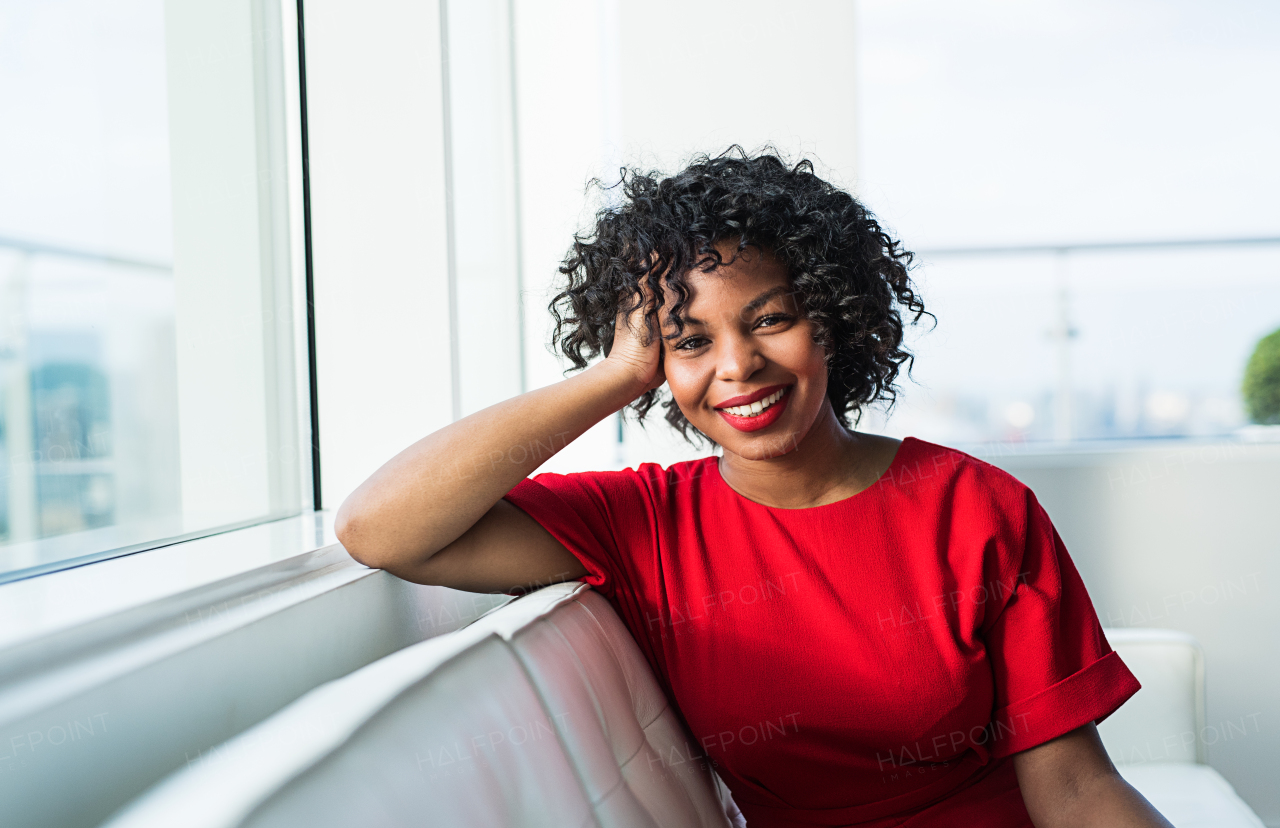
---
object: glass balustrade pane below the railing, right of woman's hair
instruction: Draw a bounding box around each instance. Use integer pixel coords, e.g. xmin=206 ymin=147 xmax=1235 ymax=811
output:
xmin=869 ymin=244 xmax=1280 ymax=443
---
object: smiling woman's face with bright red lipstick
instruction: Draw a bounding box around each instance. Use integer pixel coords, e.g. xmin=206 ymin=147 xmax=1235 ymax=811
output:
xmin=663 ymin=244 xmax=827 ymax=459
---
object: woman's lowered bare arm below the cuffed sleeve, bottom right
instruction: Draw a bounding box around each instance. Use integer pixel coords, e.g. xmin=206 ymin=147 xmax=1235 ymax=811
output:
xmin=1014 ymin=723 xmax=1172 ymax=828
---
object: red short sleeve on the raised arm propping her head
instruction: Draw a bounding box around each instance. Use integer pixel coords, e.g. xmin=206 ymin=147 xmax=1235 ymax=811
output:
xmin=506 ymin=470 xmax=648 ymax=599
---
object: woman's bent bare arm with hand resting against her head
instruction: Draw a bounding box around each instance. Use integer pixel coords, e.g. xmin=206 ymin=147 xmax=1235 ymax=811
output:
xmin=334 ymin=294 xmax=663 ymax=591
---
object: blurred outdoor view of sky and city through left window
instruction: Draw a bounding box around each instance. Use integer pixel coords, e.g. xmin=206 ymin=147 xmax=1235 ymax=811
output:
xmin=0 ymin=0 xmax=179 ymax=550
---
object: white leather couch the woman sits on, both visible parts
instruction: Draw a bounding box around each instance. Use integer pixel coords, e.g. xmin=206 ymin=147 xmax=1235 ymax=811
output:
xmin=108 ymin=584 xmax=1262 ymax=828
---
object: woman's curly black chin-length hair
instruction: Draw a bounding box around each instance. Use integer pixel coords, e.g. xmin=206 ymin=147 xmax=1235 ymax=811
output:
xmin=549 ymin=145 xmax=932 ymax=444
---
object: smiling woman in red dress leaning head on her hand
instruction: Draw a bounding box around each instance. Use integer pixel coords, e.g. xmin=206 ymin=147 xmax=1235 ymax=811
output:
xmin=337 ymin=151 xmax=1169 ymax=828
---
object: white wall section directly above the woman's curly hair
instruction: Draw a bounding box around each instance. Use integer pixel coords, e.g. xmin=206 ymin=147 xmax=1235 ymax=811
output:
xmin=617 ymin=0 xmax=856 ymax=187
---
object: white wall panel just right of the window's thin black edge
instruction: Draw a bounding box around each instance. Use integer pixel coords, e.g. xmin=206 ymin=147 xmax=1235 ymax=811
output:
xmin=305 ymin=0 xmax=452 ymax=508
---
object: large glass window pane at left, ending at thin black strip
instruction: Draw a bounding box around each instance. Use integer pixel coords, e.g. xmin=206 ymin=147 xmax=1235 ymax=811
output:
xmin=0 ymin=0 xmax=308 ymax=580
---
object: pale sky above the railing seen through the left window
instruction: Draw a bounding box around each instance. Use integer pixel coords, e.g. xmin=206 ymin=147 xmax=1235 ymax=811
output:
xmin=0 ymin=0 xmax=173 ymax=262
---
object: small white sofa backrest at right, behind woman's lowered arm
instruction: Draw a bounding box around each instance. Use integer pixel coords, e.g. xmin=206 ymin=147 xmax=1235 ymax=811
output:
xmin=1098 ymin=627 xmax=1207 ymax=765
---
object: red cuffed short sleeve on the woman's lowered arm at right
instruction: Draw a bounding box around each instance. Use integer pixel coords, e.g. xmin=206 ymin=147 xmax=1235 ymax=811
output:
xmin=984 ymin=490 xmax=1140 ymax=758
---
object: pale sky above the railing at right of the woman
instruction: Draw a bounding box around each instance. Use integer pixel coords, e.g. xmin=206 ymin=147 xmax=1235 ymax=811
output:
xmin=858 ymin=0 xmax=1280 ymax=247
